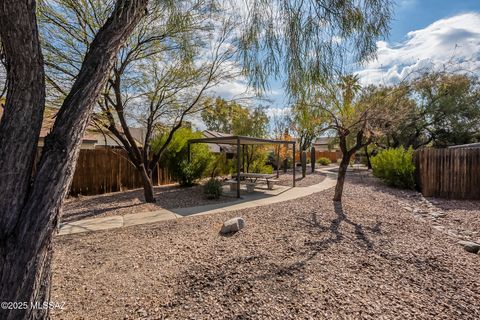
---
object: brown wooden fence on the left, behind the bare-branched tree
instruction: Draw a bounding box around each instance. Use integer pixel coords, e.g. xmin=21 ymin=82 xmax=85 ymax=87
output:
xmin=70 ymin=149 xmax=173 ymax=195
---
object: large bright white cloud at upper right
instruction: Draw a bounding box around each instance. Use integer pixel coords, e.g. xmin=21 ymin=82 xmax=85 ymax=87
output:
xmin=358 ymin=12 xmax=480 ymax=84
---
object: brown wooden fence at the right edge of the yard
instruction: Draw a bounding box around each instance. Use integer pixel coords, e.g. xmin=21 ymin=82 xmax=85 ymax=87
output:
xmin=414 ymin=148 xmax=480 ymax=199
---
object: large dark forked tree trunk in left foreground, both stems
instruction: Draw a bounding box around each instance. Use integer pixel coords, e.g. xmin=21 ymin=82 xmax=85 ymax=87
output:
xmin=0 ymin=0 xmax=147 ymax=319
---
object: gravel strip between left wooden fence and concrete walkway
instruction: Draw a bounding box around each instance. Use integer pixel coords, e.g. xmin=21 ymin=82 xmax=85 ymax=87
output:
xmin=62 ymin=185 xmax=236 ymax=222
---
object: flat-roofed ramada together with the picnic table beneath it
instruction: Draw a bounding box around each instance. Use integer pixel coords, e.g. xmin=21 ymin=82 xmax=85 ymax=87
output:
xmin=188 ymin=136 xmax=296 ymax=198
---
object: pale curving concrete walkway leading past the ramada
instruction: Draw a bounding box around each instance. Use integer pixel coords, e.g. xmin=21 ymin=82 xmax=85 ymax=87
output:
xmin=59 ymin=174 xmax=336 ymax=235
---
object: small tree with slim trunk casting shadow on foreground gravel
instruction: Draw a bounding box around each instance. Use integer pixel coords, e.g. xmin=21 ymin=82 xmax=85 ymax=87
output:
xmin=311 ymin=75 xmax=408 ymax=201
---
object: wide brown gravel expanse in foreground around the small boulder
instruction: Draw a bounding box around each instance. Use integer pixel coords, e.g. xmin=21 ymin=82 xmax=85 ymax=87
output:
xmin=52 ymin=182 xmax=480 ymax=319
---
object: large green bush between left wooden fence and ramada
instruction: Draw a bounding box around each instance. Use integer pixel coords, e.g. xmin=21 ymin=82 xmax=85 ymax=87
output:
xmin=152 ymin=127 xmax=215 ymax=186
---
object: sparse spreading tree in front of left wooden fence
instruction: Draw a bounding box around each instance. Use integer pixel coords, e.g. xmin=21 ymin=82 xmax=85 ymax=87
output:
xmin=41 ymin=0 xmax=234 ymax=202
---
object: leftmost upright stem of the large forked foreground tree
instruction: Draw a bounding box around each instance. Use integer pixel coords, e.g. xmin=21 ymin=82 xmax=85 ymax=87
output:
xmin=0 ymin=0 xmax=45 ymax=235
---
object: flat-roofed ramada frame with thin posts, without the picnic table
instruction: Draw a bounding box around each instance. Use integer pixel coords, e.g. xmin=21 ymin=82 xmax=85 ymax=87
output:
xmin=188 ymin=136 xmax=295 ymax=198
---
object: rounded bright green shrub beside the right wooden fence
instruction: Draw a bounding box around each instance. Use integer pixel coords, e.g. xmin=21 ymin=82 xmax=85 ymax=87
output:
xmin=371 ymin=147 xmax=415 ymax=189
